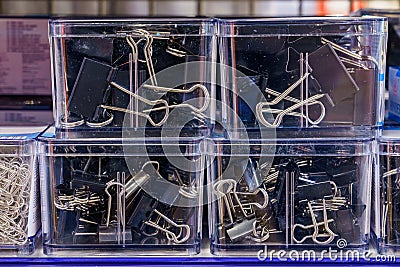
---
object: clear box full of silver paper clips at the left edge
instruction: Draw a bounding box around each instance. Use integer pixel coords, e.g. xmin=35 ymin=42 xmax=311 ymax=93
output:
xmin=0 ymin=135 xmax=41 ymax=256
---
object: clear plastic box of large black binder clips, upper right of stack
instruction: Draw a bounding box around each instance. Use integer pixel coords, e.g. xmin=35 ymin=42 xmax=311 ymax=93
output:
xmin=218 ymin=17 xmax=387 ymax=129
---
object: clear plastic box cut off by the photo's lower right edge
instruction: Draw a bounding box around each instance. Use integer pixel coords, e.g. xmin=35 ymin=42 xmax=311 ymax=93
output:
xmin=373 ymin=129 xmax=400 ymax=254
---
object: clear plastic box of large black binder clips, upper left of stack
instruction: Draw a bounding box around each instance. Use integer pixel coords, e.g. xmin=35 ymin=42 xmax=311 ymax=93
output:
xmin=50 ymin=18 xmax=216 ymax=131
